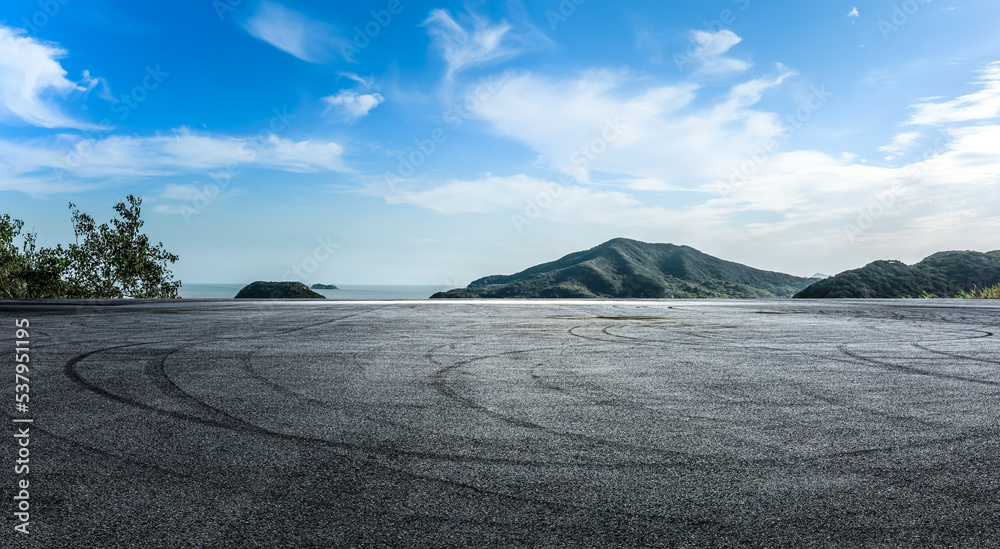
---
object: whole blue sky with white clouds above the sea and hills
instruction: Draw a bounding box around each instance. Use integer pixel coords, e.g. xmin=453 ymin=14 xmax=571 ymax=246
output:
xmin=0 ymin=0 xmax=1000 ymax=287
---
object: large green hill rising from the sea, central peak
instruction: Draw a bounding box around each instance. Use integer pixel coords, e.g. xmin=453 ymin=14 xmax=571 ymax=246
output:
xmin=431 ymin=238 xmax=816 ymax=299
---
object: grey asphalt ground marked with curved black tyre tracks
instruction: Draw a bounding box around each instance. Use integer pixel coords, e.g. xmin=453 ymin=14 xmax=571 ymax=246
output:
xmin=0 ymin=300 xmax=1000 ymax=549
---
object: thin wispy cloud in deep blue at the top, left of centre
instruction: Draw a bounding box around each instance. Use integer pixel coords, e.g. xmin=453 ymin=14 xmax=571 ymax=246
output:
xmin=243 ymin=0 xmax=353 ymax=63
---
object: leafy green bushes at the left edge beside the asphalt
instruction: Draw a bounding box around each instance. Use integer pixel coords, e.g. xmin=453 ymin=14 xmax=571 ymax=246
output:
xmin=0 ymin=195 xmax=180 ymax=299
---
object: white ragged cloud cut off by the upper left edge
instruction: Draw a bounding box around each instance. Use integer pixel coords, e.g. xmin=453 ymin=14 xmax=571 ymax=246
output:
xmin=0 ymin=25 xmax=101 ymax=129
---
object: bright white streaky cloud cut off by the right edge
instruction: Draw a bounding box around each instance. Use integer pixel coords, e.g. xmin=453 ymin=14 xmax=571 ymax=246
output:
xmin=907 ymin=61 xmax=1000 ymax=126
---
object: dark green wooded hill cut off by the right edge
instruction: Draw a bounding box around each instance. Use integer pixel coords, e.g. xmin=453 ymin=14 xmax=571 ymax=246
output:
xmin=795 ymin=250 xmax=1000 ymax=298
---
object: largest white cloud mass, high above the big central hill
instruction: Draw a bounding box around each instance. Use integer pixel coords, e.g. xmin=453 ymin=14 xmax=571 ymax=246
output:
xmin=475 ymin=67 xmax=792 ymax=184
